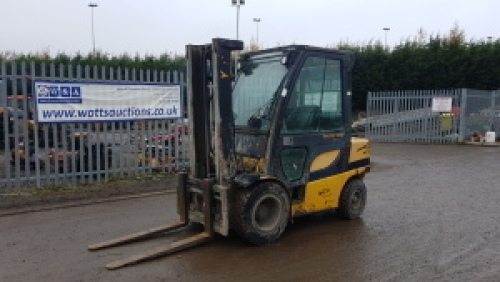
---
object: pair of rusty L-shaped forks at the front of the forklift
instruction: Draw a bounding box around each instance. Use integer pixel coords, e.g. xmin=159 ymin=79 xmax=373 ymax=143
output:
xmin=88 ymin=172 xmax=214 ymax=270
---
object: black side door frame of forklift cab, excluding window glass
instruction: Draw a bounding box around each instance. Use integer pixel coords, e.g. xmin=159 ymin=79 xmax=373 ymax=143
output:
xmin=268 ymin=47 xmax=353 ymax=200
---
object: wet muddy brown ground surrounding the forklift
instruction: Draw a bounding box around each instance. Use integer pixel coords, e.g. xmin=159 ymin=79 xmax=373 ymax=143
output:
xmin=0 ymin=144 xmax=500 ymax=281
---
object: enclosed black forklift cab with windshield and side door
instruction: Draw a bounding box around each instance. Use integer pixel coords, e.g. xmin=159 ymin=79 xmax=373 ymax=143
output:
xmin=232 ymin=46 xmax=354 ymax=205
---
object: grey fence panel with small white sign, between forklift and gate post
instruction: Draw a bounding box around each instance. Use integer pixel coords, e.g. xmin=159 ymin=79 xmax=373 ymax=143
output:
xmin=365 ymin=90 xmax=464 ymax=144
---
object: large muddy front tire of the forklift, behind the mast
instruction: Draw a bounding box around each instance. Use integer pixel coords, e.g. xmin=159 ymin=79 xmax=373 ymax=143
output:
xmin=231 ymin=182 xmax=290 ymax=245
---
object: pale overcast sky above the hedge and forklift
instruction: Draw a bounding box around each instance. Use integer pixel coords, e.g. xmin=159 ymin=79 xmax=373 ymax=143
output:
xmin=0 ymin=0 xmax=500 ymax=55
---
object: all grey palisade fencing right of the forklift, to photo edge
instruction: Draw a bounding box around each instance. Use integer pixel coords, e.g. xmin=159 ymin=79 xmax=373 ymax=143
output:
xmin=365 ymin=89 xmax=500 ymax=144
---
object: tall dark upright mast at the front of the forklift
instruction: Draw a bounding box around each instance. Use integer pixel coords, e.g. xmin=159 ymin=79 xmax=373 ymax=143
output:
xmin=186 ymin=38 xmax=243 ymax=185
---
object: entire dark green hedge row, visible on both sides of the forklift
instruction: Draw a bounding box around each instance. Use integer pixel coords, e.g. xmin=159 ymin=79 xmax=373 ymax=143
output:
xmin=0 ymin=26 xmax=500 ymax=111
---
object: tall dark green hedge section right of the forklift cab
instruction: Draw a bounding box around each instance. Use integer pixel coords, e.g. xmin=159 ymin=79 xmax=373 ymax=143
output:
xmin=343 ymin=36 xmax=500 ymax=110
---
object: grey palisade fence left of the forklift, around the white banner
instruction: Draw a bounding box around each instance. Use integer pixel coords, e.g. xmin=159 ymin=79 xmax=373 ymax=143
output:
xmin=0 ymin=62 xmax=189 ymax=189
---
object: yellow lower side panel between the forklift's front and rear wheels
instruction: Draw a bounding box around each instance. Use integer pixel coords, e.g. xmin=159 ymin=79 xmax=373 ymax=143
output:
xmin=292 ymin=168 xmax=366 ymax=217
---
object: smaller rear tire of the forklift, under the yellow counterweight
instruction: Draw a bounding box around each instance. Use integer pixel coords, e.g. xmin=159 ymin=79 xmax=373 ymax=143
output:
xmin=337 ymin=179 xmax=366 ymax=220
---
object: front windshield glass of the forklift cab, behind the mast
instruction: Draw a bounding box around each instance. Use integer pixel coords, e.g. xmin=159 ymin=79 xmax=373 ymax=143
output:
xmin=233 ymin=53 xmax=287 ymax=130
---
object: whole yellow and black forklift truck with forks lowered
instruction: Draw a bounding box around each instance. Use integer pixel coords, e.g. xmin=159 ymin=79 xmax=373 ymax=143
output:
xmin=89 ymin=39 xmax=370 ymax=269
